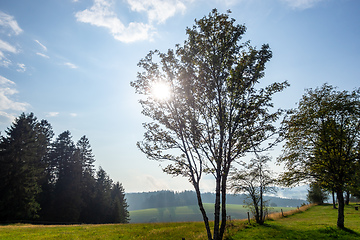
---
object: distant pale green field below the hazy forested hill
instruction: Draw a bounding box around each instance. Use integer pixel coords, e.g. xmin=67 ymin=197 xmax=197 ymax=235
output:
xmin=130 ymin=203 xmax=294 ymax=223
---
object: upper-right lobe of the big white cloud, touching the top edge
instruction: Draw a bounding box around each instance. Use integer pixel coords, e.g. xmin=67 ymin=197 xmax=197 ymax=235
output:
xmin=127 ymin=0 xmax=186 ymax=23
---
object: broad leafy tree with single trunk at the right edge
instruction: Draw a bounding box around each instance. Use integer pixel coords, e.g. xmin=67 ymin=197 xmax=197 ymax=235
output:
xmin=279 ymin=84 xmax=360 ymax=228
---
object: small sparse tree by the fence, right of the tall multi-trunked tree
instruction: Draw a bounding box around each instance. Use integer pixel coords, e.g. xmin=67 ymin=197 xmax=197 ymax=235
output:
xmin=231 ymin=156 xmax=276 ymax=224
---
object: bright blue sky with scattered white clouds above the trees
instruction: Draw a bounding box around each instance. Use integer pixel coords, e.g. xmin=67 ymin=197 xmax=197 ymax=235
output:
xmin=0 ymin=0 xmax=360 ymax=195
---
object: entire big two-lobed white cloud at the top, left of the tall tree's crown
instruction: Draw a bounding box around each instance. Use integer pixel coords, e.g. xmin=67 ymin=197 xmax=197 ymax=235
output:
xmin=75 ymin=0 xmax=191 ymax=43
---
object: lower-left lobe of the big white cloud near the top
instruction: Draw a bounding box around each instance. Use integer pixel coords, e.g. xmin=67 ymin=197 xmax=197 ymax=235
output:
xmin=75 ymin=0 xmax=151 ymax=42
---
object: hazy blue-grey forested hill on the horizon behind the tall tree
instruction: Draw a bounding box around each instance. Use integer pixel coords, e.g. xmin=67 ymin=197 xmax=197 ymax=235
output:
xmin=126 ymin=191 xmax=306 ymax=211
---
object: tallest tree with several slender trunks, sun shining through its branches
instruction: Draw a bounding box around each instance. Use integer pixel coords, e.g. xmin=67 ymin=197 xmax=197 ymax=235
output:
xmin=131 ymin=9 xmax=288 ymax=239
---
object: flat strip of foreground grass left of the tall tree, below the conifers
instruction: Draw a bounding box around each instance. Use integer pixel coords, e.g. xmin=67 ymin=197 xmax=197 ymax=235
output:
xmin=0 ymin=222 xmax=211 ymax=240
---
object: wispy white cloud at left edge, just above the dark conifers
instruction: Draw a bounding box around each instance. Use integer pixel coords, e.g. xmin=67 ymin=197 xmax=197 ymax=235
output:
xmin=0 ymin=75 xmax=29 ymax=121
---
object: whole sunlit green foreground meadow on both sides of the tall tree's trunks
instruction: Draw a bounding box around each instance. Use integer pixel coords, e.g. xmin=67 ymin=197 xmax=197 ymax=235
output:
xmin=0 ymin=204 xmax=360 ymax=240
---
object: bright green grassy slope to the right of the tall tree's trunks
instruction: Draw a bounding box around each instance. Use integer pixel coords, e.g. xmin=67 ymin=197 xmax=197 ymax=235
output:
xmin=229 ymin=204 xmax=360 ymax=239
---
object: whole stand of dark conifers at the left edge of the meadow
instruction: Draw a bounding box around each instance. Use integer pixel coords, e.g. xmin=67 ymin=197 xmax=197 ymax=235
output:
xmin=0 ymin=113 xmax=129 ymax=223
